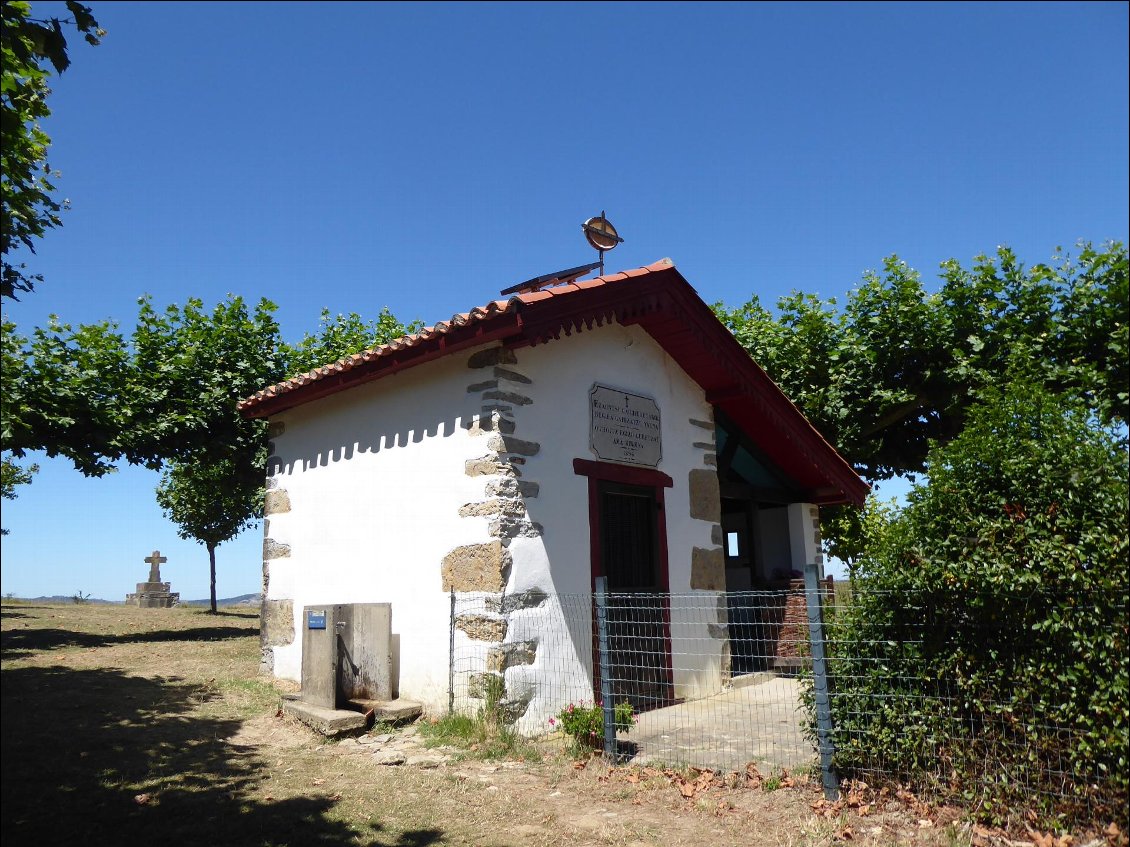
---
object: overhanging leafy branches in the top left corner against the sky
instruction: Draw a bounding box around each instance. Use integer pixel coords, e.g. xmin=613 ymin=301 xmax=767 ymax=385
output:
xmin=0 ymin=0 xmax=105 ymax=298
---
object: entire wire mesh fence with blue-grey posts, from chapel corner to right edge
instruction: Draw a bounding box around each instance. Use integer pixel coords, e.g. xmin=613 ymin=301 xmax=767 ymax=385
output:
xmin=450 ymin=580 xmax=1128 ymax=822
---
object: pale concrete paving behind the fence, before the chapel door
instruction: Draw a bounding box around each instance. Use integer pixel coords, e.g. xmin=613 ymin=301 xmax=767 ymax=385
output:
xmin=619 ymin=674 xmax=816 ymax=774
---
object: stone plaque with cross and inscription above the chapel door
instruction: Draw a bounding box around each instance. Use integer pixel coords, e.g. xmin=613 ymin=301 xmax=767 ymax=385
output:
xmin=589 ymin=385 xmax=663 ymax=468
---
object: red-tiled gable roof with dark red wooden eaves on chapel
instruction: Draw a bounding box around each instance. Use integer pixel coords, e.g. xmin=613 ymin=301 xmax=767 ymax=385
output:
xmin=238 ymin=259 xmax=868 ymax=504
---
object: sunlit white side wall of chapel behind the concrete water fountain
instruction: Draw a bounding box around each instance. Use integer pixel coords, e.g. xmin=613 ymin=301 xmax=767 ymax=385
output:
xmin=268 ymin=357 xmax=488 ymax=705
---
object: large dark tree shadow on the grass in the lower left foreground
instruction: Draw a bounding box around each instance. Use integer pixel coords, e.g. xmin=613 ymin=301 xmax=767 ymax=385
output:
xmin=0 ymin=659 xmax=443 ymax=847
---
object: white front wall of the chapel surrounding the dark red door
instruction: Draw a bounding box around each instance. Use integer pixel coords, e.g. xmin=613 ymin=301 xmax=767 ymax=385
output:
xmin=485 ymin=324 xmax=721 ymax=728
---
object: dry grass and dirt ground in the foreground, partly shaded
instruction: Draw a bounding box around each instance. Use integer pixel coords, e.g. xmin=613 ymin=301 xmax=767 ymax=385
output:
xmin=0 ymin=601 xmax=1111 ymax=847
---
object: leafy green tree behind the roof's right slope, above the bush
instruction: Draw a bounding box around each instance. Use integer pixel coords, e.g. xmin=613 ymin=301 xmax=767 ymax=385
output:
xmin=715 ymin=243 xmax=1130 ymax=481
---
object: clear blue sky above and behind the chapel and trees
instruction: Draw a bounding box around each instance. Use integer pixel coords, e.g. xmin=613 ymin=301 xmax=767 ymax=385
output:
xmin=2 ymin=0 xmax=1128 ymax=600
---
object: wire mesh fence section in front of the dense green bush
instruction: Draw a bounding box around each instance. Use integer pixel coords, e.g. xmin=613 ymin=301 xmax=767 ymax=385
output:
xmin=818 ymin=584 xmax=1130 ymax=828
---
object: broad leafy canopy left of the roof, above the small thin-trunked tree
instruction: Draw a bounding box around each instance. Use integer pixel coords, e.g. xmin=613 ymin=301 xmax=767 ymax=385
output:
xmin=0 ymin=297 xmax=285 ymax=477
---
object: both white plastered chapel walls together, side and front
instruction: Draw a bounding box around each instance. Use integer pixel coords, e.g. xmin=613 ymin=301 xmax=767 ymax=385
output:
xmin=268 ymin=325 xmax=741 ymax=732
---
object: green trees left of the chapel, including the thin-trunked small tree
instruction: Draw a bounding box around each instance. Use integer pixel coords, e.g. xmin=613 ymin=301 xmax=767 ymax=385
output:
xmin=0 ymin=297 xmax=419 ymax=609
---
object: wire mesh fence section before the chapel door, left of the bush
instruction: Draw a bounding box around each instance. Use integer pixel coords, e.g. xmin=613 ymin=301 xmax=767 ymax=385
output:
xmin=452 ymin=587 xmax=831 ymax=770
